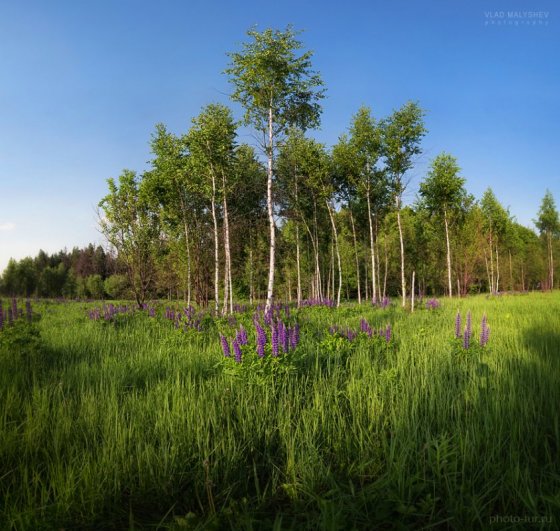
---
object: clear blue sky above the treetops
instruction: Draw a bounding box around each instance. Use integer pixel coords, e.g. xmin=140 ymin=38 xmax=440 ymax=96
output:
xmin=0 ymin=0 xmax=560 ymax=270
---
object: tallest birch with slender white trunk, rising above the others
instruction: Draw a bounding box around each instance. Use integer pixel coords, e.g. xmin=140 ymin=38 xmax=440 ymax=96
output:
xmin=225 ymin=26 xmax=324 ymax=310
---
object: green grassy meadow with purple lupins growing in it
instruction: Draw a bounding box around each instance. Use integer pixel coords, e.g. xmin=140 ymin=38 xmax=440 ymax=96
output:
xmin=0 ymin=293 xmax=560 ymax=530
